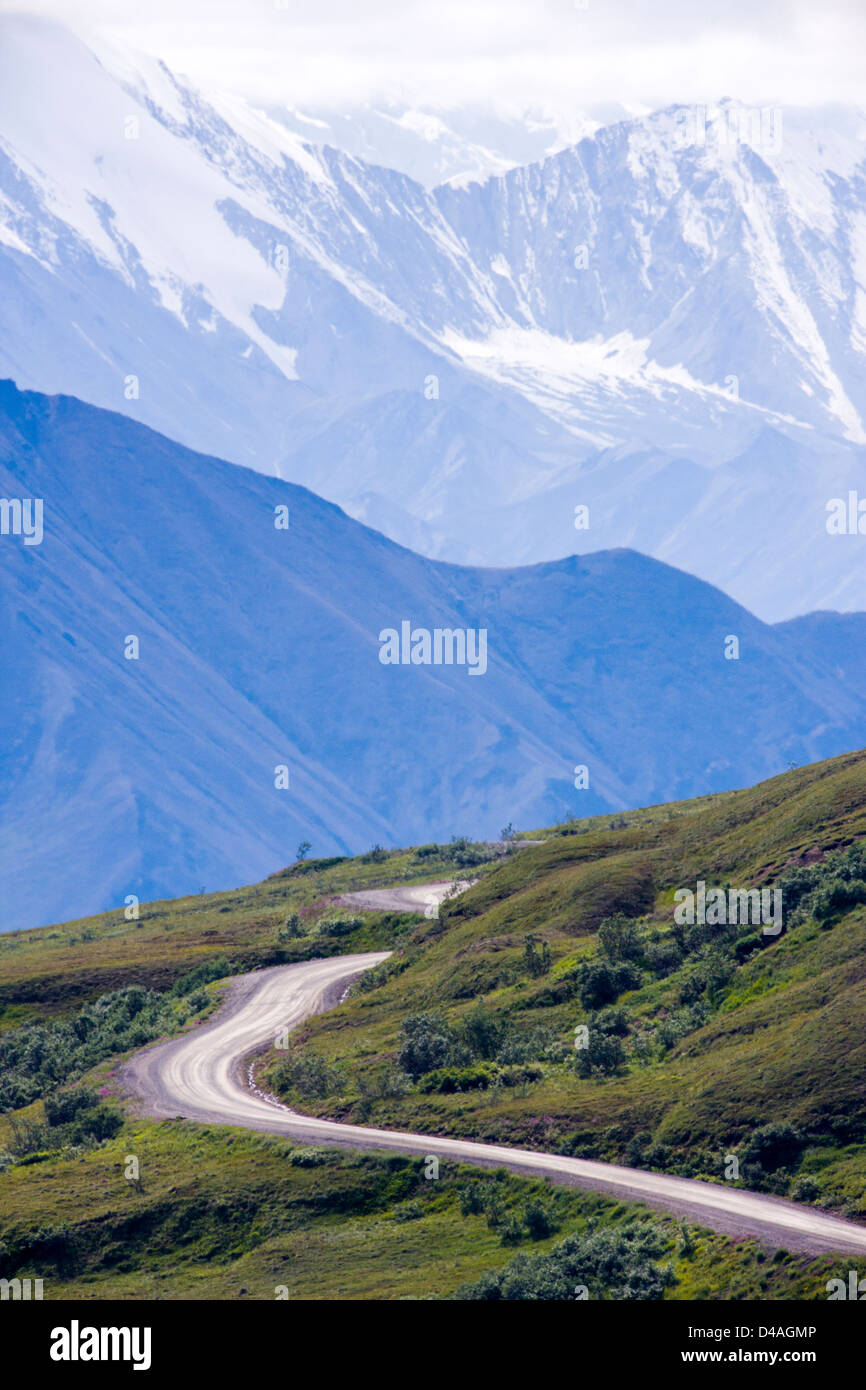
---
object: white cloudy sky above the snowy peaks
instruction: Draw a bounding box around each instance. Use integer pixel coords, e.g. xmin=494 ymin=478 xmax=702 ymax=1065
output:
xmin=0 ymin=0 xmax=866 ymax=114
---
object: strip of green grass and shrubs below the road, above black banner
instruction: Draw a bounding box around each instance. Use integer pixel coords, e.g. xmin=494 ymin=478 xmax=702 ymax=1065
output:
xmin=0 ymin=1120 xmax=866 ymax=1300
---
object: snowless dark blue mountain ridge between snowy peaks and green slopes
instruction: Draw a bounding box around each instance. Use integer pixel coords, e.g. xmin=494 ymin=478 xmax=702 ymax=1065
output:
xmin=0 ymin=382 xmax=866 ymax=929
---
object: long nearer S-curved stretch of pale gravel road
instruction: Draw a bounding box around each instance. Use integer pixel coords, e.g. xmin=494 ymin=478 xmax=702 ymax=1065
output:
xmin=121 ymin=951 xmax=866 ymax=1255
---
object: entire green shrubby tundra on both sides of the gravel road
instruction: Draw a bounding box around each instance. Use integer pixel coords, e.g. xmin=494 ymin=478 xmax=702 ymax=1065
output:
xmin=0 ymin=753 xmax=866 ymax=1298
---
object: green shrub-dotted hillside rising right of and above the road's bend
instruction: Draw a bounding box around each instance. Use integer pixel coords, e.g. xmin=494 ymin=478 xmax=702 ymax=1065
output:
xmin=263 ymin=753 xmax=866 ymax=1215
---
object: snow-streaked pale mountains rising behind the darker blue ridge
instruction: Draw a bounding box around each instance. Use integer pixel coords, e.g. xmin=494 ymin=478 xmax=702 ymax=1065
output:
xmin=0 ymin=18 xmax=866 ymax=619
